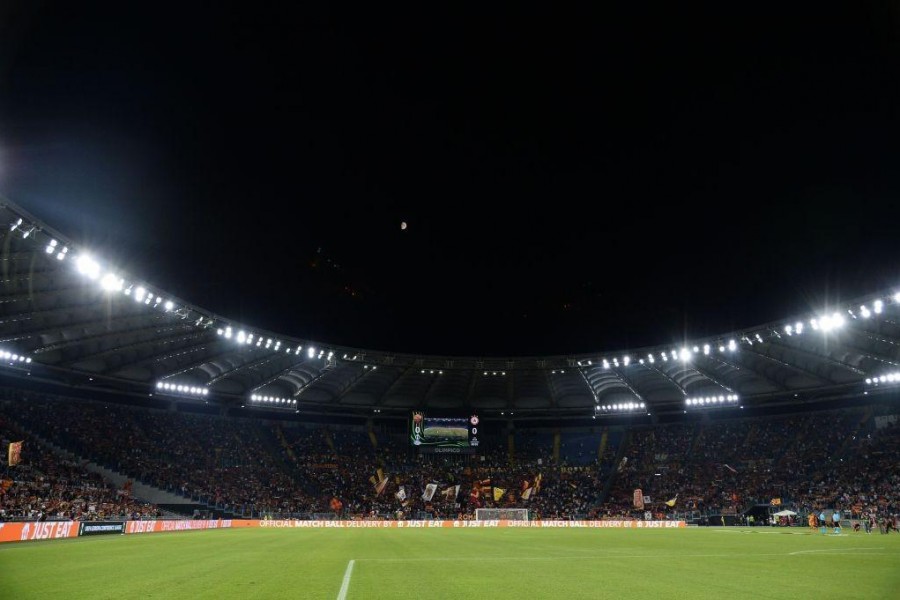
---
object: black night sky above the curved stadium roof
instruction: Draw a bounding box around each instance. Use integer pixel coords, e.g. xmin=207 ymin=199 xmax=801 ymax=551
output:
xmin=0 ymin=1 xmax=900 ymax=356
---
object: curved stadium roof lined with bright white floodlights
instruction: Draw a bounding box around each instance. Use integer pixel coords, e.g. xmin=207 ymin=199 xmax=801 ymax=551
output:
xmin=0 ymin=201 xmax=900 ymax=419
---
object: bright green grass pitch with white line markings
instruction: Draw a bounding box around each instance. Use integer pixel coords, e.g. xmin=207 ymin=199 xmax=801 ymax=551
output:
xmin=0 ymin=528 xmax=900 ymax=600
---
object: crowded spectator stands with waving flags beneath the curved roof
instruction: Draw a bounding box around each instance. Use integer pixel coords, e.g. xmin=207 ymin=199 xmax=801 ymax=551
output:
xmin=0 ymin=389 xmax=900 ymax=521
